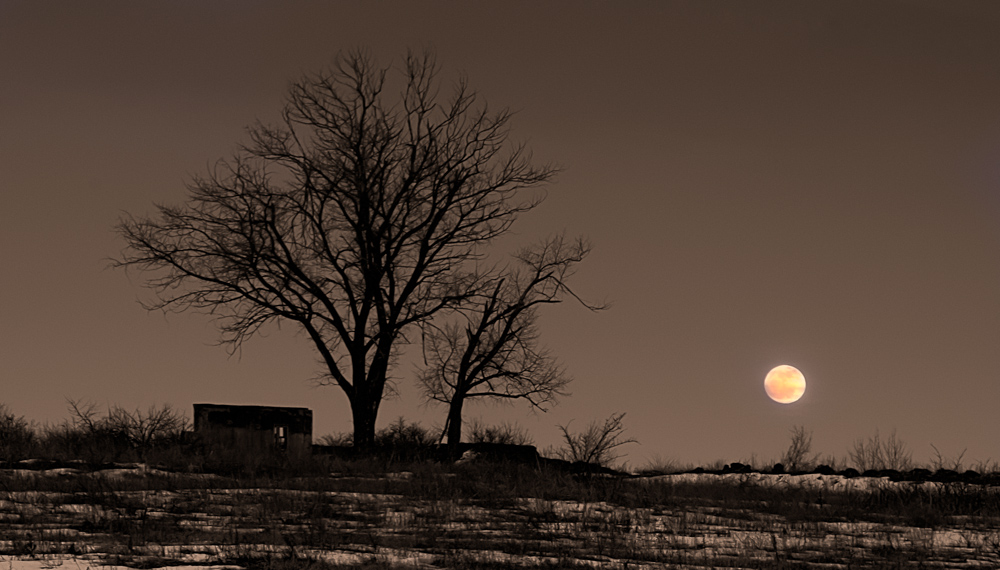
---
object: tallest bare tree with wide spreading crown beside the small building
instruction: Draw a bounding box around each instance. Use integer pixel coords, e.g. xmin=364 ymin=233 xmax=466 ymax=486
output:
xmin=116 ymin=53 xmax=554 ymax=447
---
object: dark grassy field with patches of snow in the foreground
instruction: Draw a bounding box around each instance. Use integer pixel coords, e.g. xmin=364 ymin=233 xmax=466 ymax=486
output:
xmin=0 ymin=462 xmax=1000 ymax=569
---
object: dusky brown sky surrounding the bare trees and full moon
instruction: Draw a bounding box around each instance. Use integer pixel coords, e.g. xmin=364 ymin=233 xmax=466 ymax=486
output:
xmin=0 ymin=0 xmax=1000 ymax=467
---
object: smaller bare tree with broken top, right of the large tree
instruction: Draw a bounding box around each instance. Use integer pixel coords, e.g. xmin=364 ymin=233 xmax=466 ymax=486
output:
xmin=418 ymin=235 xmax=602 ymax=449
